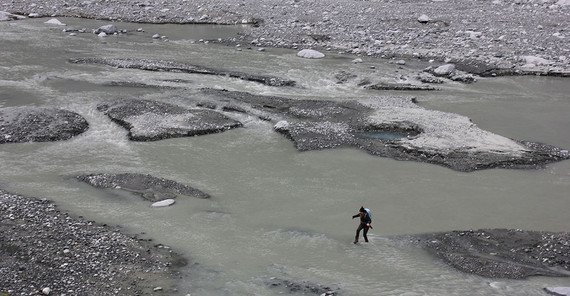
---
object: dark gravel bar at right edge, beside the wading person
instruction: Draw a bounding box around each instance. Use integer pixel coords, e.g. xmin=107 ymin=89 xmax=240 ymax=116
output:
xmin=414 ymin=229 xmax=570 ymax=279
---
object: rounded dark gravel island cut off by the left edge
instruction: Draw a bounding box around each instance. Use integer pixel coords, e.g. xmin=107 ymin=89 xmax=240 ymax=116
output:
xmin=0 ymin=107 xmax=89 ymax=144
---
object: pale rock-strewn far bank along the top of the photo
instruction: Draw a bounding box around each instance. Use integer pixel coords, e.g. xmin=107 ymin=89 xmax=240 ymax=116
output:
xmin=0 ymin=0 xmax=570 ymax=76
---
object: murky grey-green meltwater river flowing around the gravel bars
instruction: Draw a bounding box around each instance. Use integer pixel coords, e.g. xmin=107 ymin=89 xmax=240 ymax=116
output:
xmin=0 ymin=18 xmax=570 ymax=296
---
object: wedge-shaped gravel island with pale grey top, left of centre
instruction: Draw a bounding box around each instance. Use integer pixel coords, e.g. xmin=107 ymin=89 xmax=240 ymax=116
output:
xmin=97 ymin=100 xmax=242 ymax=141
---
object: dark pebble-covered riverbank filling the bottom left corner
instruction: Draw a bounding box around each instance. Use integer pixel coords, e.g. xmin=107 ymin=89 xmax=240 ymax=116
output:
xmin=0 ymin=190 xmax=186 ymax=295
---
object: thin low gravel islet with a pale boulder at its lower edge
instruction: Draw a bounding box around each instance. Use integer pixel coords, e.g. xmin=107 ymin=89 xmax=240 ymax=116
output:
xmin=76 ymin=173 xmax=210 ymax=201
